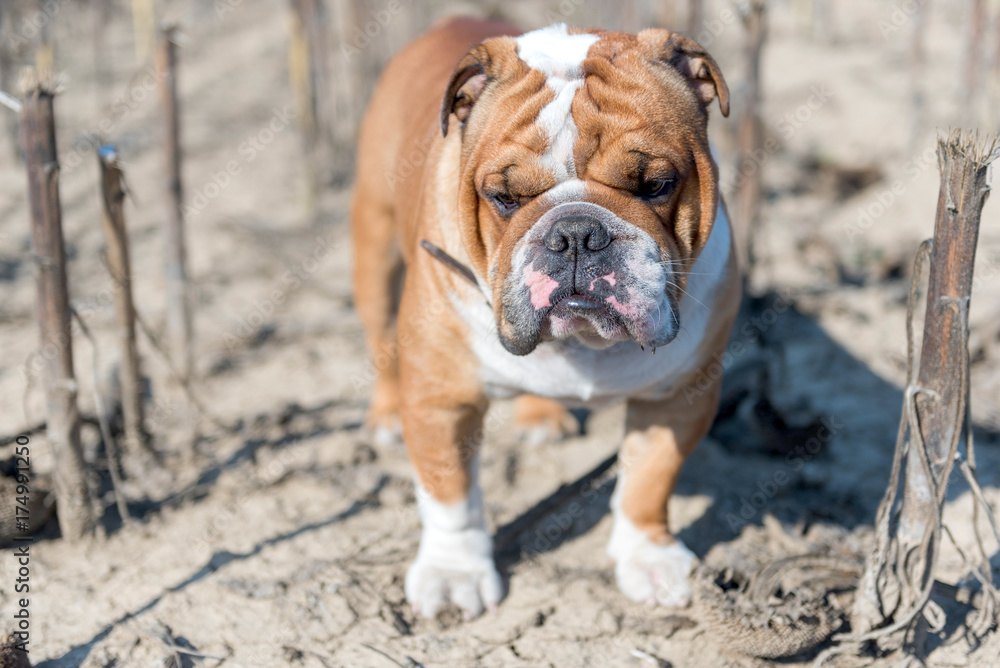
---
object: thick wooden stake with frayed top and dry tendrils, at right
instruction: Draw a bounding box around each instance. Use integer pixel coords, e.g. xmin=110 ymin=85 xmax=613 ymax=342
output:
xmin=851 ymin=132 xmax=998 ymax=654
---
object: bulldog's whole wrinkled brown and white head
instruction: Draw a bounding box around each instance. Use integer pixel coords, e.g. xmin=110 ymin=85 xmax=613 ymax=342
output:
xmin=446 ymin=26 xmax=728 ymax=355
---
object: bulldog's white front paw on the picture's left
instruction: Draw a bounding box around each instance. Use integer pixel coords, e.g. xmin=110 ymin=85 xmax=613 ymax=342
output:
xmin=406 ymin=530 xmax=503 ymax=619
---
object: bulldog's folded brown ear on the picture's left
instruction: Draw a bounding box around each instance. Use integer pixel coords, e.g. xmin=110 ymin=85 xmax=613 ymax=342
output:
xmin=441 ymin=37 xmax=517 ymax=137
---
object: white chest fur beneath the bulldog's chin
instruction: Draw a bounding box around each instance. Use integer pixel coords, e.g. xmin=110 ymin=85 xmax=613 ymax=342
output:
xmin=457 ymin=206 xmax=731 ymax=404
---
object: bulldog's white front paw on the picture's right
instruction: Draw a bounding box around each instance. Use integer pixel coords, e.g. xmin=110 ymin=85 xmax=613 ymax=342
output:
xmin=615 ymin=541 xmax=696 ymax=608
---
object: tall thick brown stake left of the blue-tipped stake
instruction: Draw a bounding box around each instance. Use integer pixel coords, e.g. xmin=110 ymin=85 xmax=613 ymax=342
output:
xmin=21 ymin=73 xmax=95 ymax=540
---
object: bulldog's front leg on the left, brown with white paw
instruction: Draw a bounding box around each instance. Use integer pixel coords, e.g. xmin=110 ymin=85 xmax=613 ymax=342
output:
xmin=401 ymin=316 xmax=503 ymax=619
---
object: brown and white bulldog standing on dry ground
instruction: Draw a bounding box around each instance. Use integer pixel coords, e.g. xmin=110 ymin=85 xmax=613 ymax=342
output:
xmin=352 ymin=19 xmax=740 ymax=617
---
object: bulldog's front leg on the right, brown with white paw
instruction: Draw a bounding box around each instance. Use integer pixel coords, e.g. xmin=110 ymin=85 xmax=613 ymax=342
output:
xmin=608 ymin=383 xmax=719 ymax=607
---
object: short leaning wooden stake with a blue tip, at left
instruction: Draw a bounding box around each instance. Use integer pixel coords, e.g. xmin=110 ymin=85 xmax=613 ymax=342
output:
xmin=97 ymin=146 xmax=149 ymax=460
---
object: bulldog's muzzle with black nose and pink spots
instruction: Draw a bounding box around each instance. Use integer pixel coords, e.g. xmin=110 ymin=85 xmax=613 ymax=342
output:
xmin=500 ymin=202 xmax=679 ymax=355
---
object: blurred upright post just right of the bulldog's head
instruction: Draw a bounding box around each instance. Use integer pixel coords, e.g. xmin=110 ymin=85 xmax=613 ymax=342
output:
xmin=734 ymin=0 xmax=767 ymax=276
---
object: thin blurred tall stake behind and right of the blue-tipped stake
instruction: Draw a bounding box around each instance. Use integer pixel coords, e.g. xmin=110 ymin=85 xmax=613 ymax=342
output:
xmin=157 ymin=26 xmax=194 ymax=379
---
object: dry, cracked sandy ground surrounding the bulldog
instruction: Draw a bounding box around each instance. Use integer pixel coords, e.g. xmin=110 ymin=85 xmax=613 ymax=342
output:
xmin=0 ymin=0 xmax=1000 ymax=668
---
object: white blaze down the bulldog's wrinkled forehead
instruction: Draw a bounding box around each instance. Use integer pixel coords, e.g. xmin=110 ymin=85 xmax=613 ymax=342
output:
xmin=517 ymin=23 xmax=600 ymax=182
